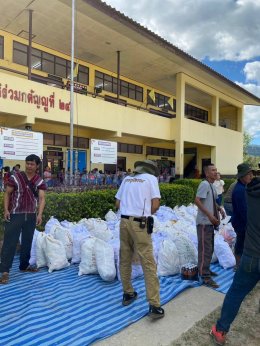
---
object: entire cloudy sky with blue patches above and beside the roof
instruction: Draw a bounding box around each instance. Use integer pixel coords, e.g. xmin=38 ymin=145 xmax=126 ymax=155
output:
xmin=105 ymin=0 xmax=260 ymax=145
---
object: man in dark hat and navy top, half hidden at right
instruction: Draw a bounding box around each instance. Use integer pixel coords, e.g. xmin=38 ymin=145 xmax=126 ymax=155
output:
xmin=232 ymin=163 xmax=253 ymax=270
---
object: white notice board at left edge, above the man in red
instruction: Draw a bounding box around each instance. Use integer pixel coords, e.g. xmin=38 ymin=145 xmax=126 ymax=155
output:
xmin=0 ymin=127 xmax=43 ymax=160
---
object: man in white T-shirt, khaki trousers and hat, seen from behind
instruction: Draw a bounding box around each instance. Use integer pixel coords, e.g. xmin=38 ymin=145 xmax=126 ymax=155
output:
xmin=116 ymin=160 xmax=164 ymax=318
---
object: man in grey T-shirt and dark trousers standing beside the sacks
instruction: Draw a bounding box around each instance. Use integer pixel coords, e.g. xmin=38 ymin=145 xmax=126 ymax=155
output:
xmin=194 ymin=164 xmax=225 ymax=288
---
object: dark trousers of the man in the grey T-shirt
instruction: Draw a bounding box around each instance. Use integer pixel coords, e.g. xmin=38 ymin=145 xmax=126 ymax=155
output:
xmin=197 ymin=225 xmax=214 ymax=278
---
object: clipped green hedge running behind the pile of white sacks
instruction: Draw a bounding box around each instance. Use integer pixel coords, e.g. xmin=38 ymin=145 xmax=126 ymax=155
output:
xmin=0 ymin=184 xmax=194 ymax=239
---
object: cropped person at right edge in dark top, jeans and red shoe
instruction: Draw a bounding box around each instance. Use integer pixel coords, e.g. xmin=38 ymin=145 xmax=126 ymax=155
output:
xmin=210 ymin=177 xmax=260 ymax=345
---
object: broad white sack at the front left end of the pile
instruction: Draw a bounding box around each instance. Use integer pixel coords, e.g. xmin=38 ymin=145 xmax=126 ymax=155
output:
xmin=44 ymin=235 xmax=70 ymax=273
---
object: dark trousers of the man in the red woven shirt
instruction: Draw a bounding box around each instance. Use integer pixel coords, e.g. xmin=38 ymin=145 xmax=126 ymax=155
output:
xmin=0 ymin=214 xmax=36 ymax=273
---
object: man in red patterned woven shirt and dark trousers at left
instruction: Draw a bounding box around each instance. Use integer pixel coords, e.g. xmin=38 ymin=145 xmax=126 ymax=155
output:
xmin=0 ymin=154 xmax=46 ymax=284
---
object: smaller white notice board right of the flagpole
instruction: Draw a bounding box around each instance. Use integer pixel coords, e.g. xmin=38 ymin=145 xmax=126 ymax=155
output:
xmin=90 ymin=139 xmax=117 ymax=165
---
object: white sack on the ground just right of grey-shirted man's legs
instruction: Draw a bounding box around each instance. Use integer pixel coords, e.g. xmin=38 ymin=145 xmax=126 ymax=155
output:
xmin=214 ymin=234 xmax=236 ymax=269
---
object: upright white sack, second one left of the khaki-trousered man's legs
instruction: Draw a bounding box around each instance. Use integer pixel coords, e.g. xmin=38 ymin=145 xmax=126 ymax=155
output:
xmin=78 ymin=237 xmax=98 ymax=276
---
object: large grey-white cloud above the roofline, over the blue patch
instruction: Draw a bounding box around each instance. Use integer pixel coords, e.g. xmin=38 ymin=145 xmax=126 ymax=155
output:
xmin=106 ymin=0 xmax=260 ymax=61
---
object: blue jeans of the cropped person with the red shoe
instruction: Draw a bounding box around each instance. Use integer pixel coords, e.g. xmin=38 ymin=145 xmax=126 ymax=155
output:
xmin=217 ymin=255 xmax=260 ymax=332
